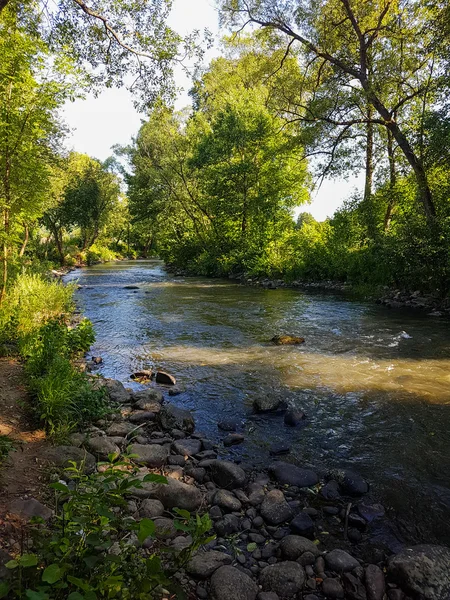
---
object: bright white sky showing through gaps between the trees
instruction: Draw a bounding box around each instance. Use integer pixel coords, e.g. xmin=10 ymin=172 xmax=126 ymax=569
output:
xmin=63 ymin=0 xmax=362 ymax=221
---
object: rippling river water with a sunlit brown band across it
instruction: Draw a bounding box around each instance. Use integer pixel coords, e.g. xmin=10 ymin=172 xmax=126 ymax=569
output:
xmin=65 ymin=261 xmax=450 ymax=543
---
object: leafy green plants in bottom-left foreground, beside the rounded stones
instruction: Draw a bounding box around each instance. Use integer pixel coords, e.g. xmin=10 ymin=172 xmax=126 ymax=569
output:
xmin=0 ymin=455 xmax=212 ymax=600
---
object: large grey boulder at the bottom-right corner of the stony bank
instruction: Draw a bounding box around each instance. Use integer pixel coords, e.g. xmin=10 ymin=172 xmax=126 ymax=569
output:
xmin=388 ymin=544 xmax=450 ymax=600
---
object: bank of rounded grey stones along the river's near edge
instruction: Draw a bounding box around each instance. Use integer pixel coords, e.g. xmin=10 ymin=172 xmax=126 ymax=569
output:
xmin=4 ymin=379 xmax=450 ymax=600
